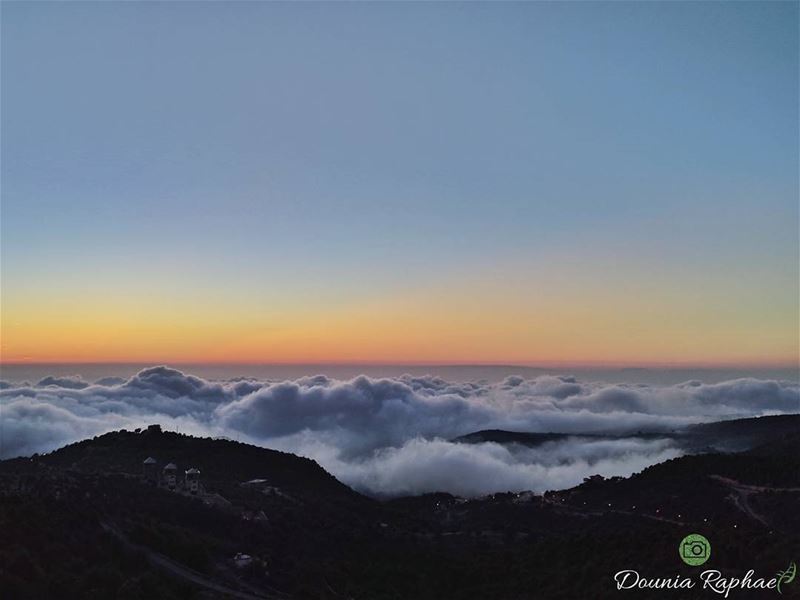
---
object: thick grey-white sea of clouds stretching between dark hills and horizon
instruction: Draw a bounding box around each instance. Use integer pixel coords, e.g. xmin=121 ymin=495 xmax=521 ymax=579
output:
xmin=0 ymin=366 xmax=800 ymax=496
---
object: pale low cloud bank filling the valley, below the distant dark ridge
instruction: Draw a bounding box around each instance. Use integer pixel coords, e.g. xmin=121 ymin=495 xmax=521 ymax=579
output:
xmin=268 ymin=433 xmax=680 ymax=497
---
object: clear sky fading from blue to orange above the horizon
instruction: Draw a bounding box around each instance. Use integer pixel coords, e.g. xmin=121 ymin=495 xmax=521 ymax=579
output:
xmin=1 ymin=2 xmax=798 ymax=365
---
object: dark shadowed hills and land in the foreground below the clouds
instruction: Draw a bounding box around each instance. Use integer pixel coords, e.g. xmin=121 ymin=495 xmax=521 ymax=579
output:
xmin=0 ymin=415 xmax=800 ymax=600
